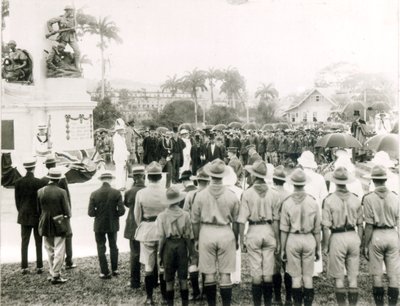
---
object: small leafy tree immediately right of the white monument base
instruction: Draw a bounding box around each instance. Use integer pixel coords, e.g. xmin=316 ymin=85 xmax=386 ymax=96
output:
xmin=93 ymin=97 xmax=122 ymax=129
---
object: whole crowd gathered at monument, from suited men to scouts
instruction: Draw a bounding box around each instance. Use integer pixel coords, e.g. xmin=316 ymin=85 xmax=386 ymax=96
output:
xmin=11 ymin=116 xmax=400 ymax=306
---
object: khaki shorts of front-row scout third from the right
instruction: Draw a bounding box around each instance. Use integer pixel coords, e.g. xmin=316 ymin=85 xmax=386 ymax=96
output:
xmin=286 ymin=233 xmax=316 ymax=277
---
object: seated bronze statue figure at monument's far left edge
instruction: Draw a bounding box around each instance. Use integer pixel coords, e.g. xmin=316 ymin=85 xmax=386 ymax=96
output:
xmin=1 ymin=40 xmax=33 ymax=84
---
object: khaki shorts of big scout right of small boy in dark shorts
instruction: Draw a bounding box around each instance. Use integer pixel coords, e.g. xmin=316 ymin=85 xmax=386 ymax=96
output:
xmin=199 ymin=224 xmax=236 ymax=274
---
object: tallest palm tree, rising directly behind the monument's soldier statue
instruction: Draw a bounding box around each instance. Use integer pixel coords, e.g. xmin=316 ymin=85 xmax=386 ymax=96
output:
xmin=83 ymin=16 xmax=122 ymax=99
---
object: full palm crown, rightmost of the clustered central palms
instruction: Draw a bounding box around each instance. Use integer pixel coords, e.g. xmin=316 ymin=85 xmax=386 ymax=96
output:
xmin=220 ymin=67 xmax=246 ymax=108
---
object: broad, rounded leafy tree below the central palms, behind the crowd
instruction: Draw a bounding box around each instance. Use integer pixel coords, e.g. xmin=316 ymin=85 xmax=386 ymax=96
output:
xmin=157 ymin=100 xmax=201 ymax=128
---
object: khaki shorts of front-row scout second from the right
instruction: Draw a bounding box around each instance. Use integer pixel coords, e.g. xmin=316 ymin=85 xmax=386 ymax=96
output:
xmin=328 ymin=231 xmax=361 ymax=278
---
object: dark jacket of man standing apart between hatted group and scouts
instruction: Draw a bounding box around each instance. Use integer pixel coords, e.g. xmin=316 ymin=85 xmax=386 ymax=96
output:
xmin=88 ymin=183 xmax=125 ymax=233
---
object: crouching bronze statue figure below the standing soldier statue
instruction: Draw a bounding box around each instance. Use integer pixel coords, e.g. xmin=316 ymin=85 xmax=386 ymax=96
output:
xmin=46 ymin=42 xmax=81 ymax=78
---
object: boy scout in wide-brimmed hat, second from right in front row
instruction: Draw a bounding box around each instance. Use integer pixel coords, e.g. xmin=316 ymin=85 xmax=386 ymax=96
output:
xmin=322 ymin=167 xmax=363 ymax=305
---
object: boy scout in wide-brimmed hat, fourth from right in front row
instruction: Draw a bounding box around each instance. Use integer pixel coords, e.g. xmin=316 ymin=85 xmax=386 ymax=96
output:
xmin=237 ymin=160 xmax=280 ymax=306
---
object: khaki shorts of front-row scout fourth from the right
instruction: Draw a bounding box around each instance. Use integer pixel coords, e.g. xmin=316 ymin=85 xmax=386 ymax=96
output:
xmin=246 ymin=224 xmax=276 ymax=277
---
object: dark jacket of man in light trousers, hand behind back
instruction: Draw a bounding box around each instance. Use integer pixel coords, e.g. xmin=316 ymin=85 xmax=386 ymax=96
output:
xmin=38 ymin=183 xmax=71 ymax=237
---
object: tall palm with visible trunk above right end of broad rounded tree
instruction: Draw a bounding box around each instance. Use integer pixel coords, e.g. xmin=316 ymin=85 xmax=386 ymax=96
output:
xmin=181 ymin=68 xmax=207 ymax=126
